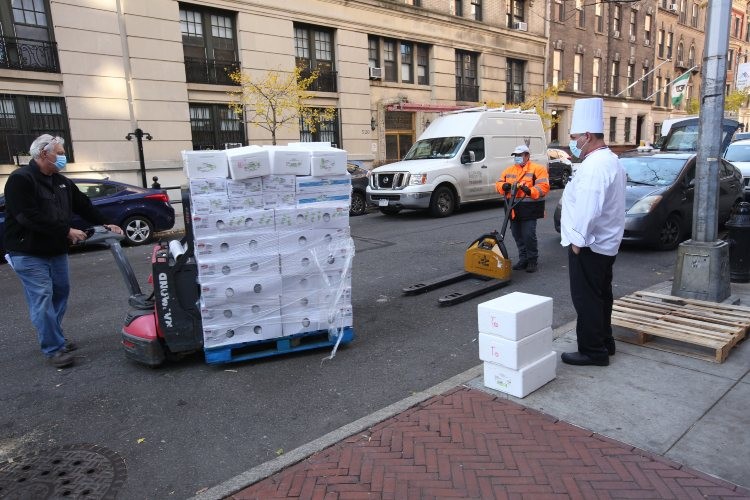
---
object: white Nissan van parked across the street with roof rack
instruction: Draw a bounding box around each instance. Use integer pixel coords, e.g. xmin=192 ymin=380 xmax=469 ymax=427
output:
xmin=367 ymin=107 xmax=547 ymax=217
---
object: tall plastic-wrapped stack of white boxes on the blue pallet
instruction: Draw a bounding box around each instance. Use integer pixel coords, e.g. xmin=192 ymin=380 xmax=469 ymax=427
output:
xmin=183 ymin=143 xmax=354 ymax=348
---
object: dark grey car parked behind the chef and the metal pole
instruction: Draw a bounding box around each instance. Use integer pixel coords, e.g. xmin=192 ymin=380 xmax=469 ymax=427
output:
xmin=554 ymin=152 xmax=743 ymax=250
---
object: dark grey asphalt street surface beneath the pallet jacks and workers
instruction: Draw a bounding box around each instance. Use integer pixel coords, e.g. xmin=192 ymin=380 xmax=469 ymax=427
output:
xmin=0 ymin=190 xmax=675 ymax=499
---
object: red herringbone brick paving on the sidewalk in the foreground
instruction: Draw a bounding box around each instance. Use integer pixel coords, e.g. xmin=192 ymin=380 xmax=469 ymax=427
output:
xmin=232 ymin=387 xmax=750 ymax=500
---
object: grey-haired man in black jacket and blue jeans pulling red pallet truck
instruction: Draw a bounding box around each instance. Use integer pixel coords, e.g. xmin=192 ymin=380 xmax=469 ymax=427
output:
xmin=5 ymin=134 xmax=122 ymax=368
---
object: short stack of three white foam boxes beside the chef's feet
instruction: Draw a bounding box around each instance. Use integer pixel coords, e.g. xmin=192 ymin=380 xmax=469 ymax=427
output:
xmin=477 ymin=292 xmax=557 ymax=398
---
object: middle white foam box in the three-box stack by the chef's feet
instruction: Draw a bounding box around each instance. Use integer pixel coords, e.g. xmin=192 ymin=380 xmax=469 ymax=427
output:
xmin=479 ymin=327 xmax=552 ymax=370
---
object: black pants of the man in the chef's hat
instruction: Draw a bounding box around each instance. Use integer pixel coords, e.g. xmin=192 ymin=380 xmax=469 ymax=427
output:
xmin=568 ymin=248 xmax=616 ymax=360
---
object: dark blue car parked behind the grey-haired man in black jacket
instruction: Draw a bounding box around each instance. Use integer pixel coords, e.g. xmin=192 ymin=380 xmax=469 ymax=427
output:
xmin=0 ymin=179 xmax=175 ymax=257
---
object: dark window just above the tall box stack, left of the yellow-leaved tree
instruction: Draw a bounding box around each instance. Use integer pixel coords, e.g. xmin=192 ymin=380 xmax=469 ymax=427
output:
xmin=189 ymin=104 xmax=245 ymax=150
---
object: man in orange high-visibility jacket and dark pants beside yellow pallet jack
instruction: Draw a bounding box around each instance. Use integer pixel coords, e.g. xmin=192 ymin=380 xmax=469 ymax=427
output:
xmin=495 ymin=144 xmax=549 ymax=273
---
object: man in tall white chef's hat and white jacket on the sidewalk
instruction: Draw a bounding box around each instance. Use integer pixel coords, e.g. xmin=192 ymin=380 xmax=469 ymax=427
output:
xmin=560 ymin=98 xmax=626 ymax=366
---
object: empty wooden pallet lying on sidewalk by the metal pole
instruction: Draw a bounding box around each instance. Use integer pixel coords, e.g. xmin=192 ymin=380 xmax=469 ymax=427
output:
xmin=612 ymin=292 xmax=750 ymax=363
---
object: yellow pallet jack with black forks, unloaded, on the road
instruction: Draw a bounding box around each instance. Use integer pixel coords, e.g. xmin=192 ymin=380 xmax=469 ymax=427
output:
xmin=402 ymin=183 xmax=521 ymax=306
